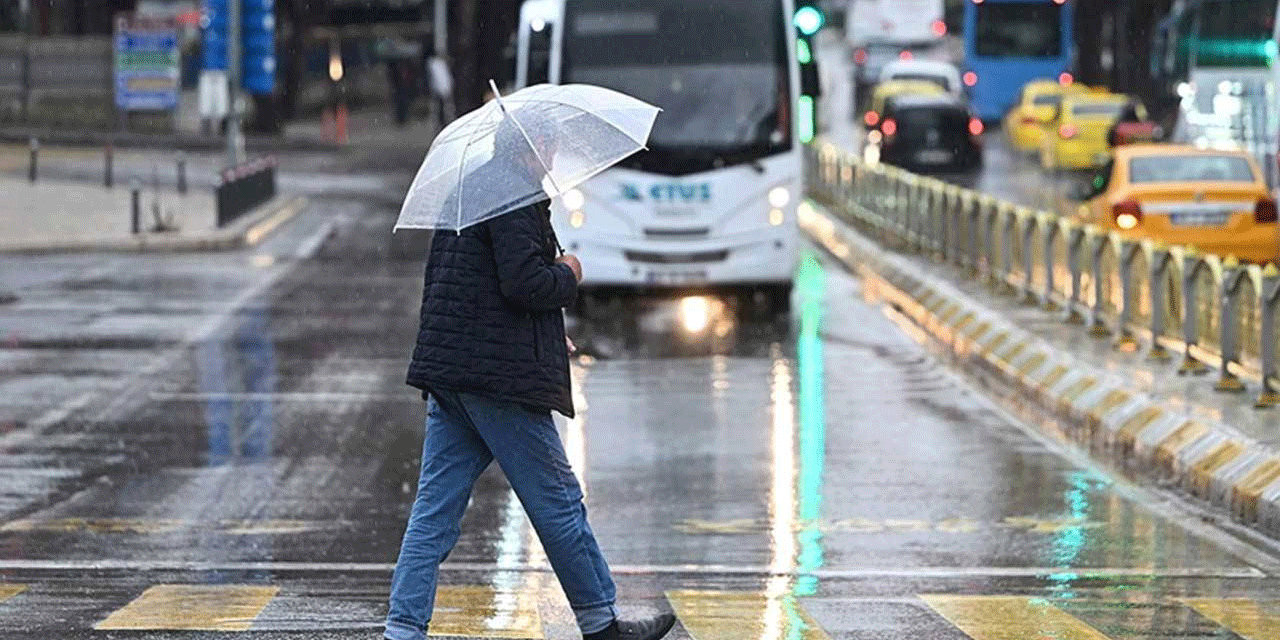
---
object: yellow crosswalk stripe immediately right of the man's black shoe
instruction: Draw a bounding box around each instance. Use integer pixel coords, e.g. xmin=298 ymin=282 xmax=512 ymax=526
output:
xmin=667 ymin=590 xmax=831 ymax=640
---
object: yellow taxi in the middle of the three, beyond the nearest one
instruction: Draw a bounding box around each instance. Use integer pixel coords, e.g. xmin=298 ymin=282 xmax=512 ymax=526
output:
xmin=1039 ymin=92 xmax=1147 ymax=169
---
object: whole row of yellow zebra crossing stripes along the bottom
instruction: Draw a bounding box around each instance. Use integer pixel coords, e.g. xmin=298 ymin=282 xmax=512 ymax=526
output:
xmin=0 ymin=584 xmax=1280 ymax=640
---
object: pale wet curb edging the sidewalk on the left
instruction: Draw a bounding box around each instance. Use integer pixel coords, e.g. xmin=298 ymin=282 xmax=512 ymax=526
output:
xmin=0 ymin=196 xmax=311 ymax=255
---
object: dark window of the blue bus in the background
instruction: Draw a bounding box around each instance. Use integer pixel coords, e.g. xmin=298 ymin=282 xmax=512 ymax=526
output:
xmin=974 ymin=3 xmax=1062 ymax=58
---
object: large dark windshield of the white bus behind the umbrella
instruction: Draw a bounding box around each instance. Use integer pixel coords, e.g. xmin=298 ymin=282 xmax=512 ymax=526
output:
xmin=562 ymin=0 xmax=791 ymax=170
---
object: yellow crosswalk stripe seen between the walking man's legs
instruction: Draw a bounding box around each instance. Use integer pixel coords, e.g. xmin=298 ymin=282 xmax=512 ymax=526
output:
xmin=431 ymin=585 xmax=544 ymax=640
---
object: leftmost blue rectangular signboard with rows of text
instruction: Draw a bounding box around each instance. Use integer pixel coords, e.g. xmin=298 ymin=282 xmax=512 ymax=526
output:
xmin=115 ymin=17 xmax=182 ymax=111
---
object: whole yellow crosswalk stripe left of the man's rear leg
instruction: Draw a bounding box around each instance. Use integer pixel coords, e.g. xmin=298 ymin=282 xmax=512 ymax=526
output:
xmin=93 ymin=585 xmax=280 ymax=631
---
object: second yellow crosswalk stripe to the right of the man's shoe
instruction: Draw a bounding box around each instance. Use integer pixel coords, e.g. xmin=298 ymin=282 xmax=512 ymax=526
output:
xmin=920 ymin=595 xmax=1107 ymax=640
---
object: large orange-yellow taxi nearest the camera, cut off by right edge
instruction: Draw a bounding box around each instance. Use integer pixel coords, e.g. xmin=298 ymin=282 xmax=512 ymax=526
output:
xmin=1080 ymin=143 xmax=1280 ymax=262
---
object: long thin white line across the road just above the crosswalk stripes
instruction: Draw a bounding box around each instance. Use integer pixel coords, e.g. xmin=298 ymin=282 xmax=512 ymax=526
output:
xmin=0 ymin=559 xmax=1267 ymax=580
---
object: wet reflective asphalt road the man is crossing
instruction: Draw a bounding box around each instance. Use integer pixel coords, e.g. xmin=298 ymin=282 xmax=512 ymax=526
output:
xmin=0 ymin=152 xmax=1280 ymax=640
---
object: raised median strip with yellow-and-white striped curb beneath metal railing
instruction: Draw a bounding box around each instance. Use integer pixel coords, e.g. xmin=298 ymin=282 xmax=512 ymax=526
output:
xmin=801 ymin=202 xmax=1280 ymax=535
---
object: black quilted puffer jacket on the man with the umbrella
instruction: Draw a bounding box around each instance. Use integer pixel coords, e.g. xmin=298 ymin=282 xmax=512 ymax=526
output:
xmin=407 ymin=201 xmax=577 ymax=417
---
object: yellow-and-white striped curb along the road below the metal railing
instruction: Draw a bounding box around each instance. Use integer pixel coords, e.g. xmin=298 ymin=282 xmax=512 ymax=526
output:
xmin=800 ymin=205 xmax=1280 ymax=535
